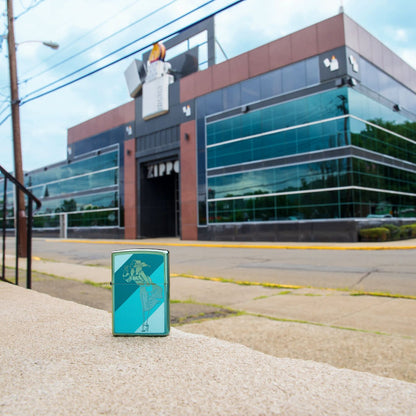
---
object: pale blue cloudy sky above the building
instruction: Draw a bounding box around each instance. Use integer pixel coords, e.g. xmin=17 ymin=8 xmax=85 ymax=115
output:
xmin=0 ymin=0 xmax=416 ymax=171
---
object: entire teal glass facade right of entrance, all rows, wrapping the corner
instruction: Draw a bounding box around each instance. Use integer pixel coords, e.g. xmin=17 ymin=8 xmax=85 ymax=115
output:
xmin=204 ymin=83 xmax=416 ymax=225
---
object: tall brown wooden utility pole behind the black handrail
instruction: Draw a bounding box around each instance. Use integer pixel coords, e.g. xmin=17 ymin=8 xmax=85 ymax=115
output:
xmin=7 ymin=0 xmax=27 ymax=257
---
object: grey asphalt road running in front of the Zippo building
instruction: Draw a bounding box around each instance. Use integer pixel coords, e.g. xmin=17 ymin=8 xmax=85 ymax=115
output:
xmin=22 ymin=238 xmax=416 ymax=296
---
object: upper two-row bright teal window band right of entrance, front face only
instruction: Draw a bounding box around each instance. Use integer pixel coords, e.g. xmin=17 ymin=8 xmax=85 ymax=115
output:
xmin=207 ymin=88 xmax=349 ymax=169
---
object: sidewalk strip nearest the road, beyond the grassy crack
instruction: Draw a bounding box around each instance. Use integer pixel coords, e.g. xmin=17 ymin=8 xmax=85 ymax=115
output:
xmin=11 ymin=256 xmax=416 ymax=338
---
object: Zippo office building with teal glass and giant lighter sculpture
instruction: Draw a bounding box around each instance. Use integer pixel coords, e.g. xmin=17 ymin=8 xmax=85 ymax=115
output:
xmin=22 ymin=13 xmax=416 ymax=241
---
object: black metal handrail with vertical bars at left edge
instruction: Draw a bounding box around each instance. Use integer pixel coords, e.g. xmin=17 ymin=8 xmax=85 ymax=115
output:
xmin=0 ymin=166 xmax=42 ymax=289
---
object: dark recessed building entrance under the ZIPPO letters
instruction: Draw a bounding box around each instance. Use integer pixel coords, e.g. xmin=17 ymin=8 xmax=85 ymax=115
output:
xmin=139 ymin=162 xmax=180 ymax=238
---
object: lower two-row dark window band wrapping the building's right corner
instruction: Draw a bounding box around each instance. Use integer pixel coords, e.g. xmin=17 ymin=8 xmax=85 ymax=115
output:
xmin=208 ymin=158 xmax=416 ymax=223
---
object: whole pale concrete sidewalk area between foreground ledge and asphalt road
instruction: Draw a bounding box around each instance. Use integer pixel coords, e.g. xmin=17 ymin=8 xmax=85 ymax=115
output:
xmin=8 ymin=252 xmax=416 ymax=383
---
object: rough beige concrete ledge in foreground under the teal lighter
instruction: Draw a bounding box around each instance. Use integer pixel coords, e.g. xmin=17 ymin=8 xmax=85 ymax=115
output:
xmin=0 ymin=282 xmax=416 ymax=416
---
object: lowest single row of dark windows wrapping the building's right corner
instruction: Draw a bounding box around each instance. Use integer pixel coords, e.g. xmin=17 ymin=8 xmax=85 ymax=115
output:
xmin=208 ymin=189 xmax=416 ymax=224
